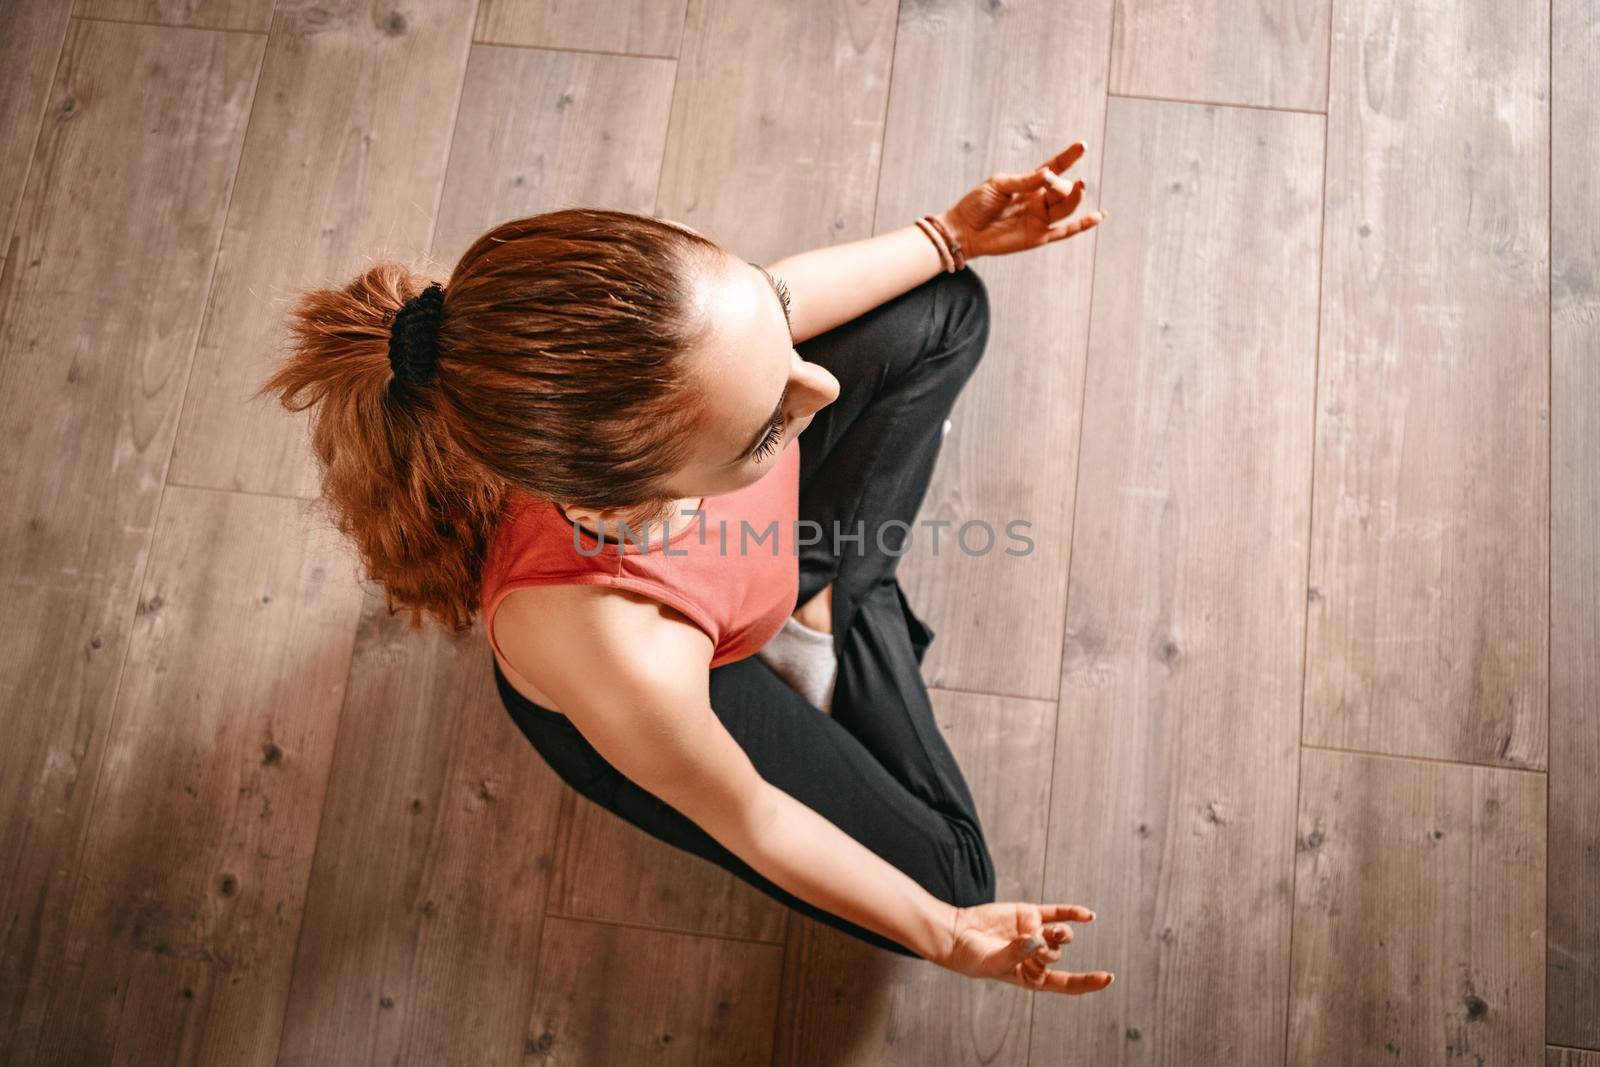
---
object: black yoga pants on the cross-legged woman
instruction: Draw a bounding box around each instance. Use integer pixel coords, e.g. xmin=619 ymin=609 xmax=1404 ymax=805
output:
xmin=494 ymin=267 xmax=995 ymax=957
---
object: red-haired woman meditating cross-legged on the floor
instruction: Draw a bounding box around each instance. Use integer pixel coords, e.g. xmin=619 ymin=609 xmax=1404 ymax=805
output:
xmin=262 ymin=144 xmax=1112 ymax=993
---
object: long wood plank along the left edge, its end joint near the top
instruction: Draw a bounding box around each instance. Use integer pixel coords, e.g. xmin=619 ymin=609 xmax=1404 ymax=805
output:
xmin=0 ymin=22 xmax=261 ymax=1062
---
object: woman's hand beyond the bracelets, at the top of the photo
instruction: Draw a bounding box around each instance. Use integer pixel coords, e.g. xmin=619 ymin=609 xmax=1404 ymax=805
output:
xmin=939 ymin=141 xmax=1106 ymax=259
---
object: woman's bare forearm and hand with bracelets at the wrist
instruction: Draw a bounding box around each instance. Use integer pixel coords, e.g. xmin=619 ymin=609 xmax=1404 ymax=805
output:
xmin=766 ymin=142 xmax=1106 ymax=342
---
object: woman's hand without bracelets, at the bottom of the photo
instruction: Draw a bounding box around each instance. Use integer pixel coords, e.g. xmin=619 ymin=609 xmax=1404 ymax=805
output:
xmin=934 ymin=902 xmax=1114 ymax=993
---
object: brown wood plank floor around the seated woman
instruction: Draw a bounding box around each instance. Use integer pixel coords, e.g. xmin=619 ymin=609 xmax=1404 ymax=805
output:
xmin=0 ymin=0 xmax=1600 ymax=1067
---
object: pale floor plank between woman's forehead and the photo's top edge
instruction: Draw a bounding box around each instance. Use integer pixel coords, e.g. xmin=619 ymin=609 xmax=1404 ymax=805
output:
xmin=656 ymin=0 xmax=899 ymax=262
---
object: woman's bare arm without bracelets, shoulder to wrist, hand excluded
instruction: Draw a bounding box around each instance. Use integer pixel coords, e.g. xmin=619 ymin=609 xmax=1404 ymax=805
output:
xmin=496 ymin=585 xmax=958 ymax=963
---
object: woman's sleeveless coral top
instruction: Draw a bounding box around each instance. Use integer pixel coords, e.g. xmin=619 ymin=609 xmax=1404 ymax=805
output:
xmin=482 ymin=440 xmax=800 ymax=667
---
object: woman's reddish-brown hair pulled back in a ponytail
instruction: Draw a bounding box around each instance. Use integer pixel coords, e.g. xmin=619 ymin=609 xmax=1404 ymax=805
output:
xmin=256 ymin=208 xmax=723 ymax=632
